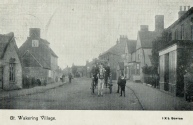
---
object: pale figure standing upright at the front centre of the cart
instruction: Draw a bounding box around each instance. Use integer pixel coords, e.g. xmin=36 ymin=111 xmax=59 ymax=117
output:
xmin=98 ymin=63 xmax=105 ymax=96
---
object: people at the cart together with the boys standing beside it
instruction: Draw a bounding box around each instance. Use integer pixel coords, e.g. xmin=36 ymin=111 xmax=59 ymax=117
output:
xmin=91 ymin=63 xmax=126 ymax=97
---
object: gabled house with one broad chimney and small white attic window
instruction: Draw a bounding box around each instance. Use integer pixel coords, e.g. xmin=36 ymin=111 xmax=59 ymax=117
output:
xmin=19 ymin=28 xmax=59 ymax=83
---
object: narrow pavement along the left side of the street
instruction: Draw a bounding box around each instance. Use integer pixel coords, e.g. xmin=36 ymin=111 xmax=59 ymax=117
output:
xmin=0 ymin=82 xmax=66 ymax=99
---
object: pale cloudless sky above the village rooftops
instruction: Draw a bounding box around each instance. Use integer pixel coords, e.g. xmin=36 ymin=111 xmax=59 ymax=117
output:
xmin=0 ymin=0 xmax=193 ymax=68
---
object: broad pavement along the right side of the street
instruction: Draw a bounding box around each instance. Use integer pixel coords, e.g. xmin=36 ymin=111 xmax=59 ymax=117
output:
xmin=126 ymin=81 xmax=193 ymax=110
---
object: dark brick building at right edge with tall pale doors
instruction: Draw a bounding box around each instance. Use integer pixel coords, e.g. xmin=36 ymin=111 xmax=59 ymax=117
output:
xmin=159 ymin=6 xmax=193 ymax=96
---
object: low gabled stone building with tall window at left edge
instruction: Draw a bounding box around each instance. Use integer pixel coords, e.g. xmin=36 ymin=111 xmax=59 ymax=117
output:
xmin=0 ymin=33 xmax=22 ymax=90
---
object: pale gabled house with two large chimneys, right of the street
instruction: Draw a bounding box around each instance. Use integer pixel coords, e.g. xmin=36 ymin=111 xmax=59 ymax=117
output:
xmin=124 ymin=15 xmax=164 ymax=82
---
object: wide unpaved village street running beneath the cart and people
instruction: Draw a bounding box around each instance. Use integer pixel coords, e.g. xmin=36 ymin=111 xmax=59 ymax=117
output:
xmin=0 ymin=78 xmax=142 ymax=110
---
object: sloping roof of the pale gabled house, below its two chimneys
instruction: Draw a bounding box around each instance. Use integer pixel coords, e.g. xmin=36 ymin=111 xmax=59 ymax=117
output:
xmin=138 ymin=31 xmax=161 ymax=48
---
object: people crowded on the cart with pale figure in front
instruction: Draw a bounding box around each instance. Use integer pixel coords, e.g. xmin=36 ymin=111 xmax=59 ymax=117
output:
xmin=91 ymin=63 xmax=110 ymax=97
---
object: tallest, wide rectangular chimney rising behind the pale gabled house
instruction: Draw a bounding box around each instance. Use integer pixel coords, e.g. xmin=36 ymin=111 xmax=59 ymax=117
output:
xmin=155 ymin=15 xmax=164 ymax=32
